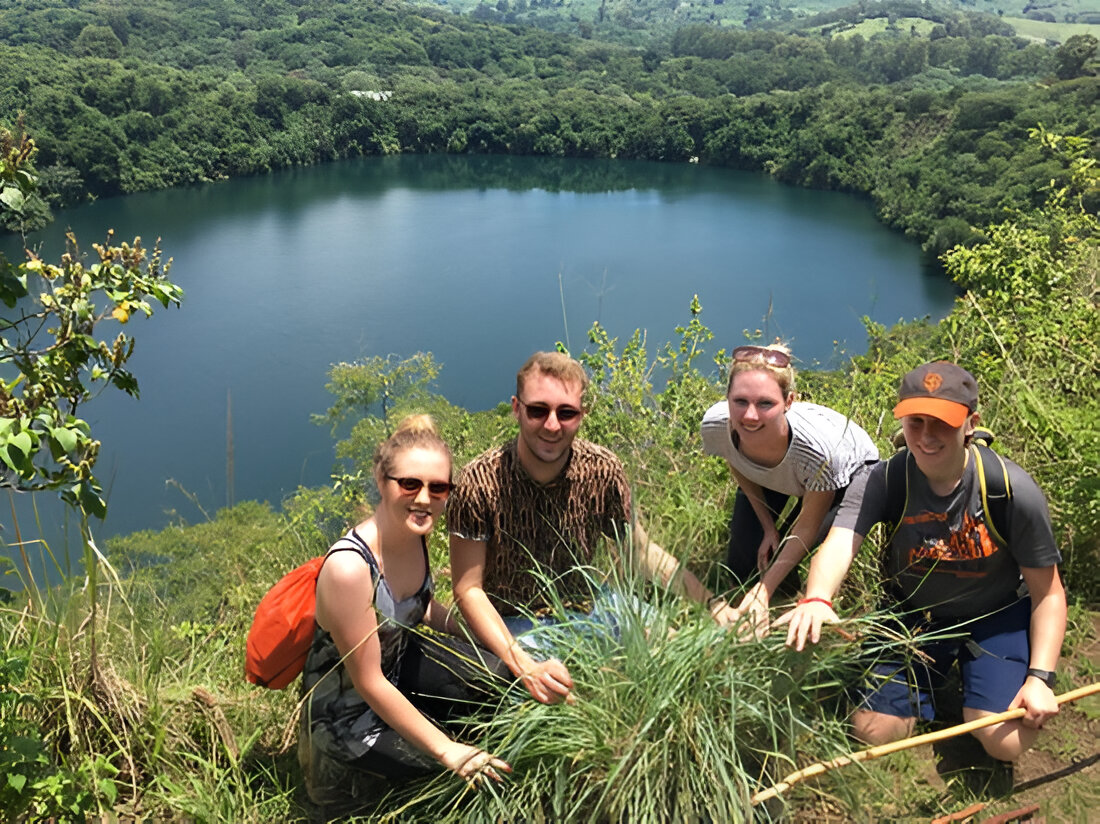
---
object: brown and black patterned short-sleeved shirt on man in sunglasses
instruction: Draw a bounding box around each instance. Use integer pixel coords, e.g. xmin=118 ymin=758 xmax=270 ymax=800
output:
xmin=447 ymin=438 xmax=630 ymax=615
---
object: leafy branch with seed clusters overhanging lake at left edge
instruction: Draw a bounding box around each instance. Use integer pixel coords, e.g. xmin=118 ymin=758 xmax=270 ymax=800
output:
xmin=0 ymin=127 xmax=183 ymax=518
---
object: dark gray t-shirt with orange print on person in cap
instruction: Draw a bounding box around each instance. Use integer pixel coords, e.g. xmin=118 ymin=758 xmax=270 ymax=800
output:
xmin=834 ymin=458 xmax=1062 ymax=618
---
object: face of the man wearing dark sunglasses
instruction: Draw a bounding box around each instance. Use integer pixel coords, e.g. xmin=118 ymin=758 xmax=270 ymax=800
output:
xmin=512 ymin=372 xmax=584 ymax=483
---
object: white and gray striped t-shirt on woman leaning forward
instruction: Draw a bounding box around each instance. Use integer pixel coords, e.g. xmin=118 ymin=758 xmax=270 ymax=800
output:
xmin=702 ymin=400 xmax=879 ymax=497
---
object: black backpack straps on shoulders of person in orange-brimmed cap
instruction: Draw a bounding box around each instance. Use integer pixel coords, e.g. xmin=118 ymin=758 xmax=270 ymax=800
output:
xmin=887 ymin=428 xmax=1012 ymax=548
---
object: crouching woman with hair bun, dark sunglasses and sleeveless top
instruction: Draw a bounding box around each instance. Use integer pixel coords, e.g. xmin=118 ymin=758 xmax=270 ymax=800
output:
xmin=298 ymin=415 xmax=510 ymax=806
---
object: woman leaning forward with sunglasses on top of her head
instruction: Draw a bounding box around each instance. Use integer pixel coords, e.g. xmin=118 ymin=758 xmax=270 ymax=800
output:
xmin=703 ymin=343 xmax=879 ymax=631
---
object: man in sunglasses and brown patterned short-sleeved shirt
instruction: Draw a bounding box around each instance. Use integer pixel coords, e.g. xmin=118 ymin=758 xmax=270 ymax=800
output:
xmin=447 ymin=352 xmax=734 ymax=704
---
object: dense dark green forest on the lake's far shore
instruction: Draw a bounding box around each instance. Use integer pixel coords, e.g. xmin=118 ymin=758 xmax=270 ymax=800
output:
xmin=0 ymin=0 xmax=1100 ymax=254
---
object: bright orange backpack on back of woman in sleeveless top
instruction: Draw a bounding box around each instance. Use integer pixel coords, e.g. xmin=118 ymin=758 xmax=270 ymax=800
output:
xmin=244 ymin=530 xmax=376 ymax=690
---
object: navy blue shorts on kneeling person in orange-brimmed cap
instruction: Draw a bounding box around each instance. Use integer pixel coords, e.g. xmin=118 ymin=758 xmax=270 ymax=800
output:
xmin=859 ymin=597 xmax=1031 ymax=721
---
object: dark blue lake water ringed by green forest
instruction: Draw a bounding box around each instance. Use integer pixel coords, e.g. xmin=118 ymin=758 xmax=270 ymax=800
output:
xmin=0 ymin=155 xmax=953 ymax=576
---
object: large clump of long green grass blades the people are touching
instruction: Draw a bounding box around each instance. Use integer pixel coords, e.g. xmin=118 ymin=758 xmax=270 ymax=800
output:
xmin=391 ymin=558 xmax=856 ymax=822
